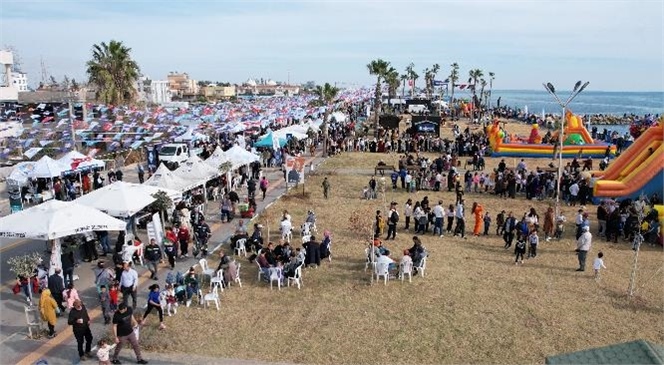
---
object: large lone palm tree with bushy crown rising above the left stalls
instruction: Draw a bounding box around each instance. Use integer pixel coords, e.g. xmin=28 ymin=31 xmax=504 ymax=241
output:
xmin=87 ymin=40 xmax=140 ymax=105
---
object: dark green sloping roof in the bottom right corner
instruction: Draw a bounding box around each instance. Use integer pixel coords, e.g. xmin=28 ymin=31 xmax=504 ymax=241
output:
xmin=546 ymin=340 xmax=664 ymax=365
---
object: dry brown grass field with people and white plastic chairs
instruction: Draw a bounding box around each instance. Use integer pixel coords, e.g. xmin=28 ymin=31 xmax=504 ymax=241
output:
xmin=141 ymin=134 xmax=664 ymax=364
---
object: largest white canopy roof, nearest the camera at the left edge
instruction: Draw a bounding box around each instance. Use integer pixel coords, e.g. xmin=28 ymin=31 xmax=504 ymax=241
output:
xmin=0 ymin=200 xmax=127 ymax=240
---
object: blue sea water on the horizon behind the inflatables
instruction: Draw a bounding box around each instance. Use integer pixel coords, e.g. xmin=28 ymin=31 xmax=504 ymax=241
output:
xmin=491 ymin=90 xmax=664 ymax=115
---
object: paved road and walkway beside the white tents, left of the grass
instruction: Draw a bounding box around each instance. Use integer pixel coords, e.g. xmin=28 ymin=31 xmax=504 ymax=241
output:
xmin=0 ymin=158 xmax=322 ymax=365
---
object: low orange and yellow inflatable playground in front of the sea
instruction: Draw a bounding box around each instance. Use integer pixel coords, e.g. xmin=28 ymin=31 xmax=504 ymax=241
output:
xmin=487 ymin=111 xmax=616 ymax=158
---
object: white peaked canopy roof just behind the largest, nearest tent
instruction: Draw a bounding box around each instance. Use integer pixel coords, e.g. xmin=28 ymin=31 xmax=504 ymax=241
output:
xmin=75 ymin=181 xmax=182 ymax=218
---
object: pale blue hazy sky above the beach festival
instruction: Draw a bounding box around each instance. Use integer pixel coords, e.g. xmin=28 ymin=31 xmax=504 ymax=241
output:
xmin=0 ymin=0 xmax=664 ymax=91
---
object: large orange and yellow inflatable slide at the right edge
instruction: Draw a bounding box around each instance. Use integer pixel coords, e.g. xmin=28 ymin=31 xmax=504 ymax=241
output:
xmin=594 ymin=121 xmax=664 ymax=199
